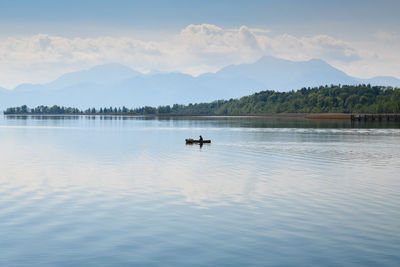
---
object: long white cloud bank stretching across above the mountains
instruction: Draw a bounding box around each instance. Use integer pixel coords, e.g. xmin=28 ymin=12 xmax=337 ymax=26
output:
xmin=0 ymin=24 xmax=400 ymax=87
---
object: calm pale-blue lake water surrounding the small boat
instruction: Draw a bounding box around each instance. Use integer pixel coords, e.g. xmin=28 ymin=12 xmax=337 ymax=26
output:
xmin=0 ymin=117 xmax=400 ymax=266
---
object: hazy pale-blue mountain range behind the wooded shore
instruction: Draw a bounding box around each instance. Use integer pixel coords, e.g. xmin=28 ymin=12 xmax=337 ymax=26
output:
xmin=0 ymin=57 xmax=400 ymax=109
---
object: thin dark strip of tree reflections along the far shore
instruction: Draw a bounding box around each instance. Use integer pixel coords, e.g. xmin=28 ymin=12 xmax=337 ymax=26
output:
xmin=5 ymin=115 xmax=400 ymax=129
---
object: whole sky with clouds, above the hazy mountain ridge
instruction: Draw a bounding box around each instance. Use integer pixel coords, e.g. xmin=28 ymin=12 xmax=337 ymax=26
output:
xmin=0 ymin=0 xmax=400 ymax=89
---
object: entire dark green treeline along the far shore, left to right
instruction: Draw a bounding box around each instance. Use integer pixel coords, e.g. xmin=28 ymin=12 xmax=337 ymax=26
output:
xmin=4 ymin=85 xmax=400 ymax=115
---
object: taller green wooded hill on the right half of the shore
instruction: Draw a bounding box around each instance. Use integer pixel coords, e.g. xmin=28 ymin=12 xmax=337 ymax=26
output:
xmin=216 ymin=85 xmax=400 ymax=114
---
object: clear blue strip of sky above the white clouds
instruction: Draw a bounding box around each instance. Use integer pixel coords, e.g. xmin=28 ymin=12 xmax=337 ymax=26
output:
xmin=0 ymin=0 xmax=400 ymax=38
